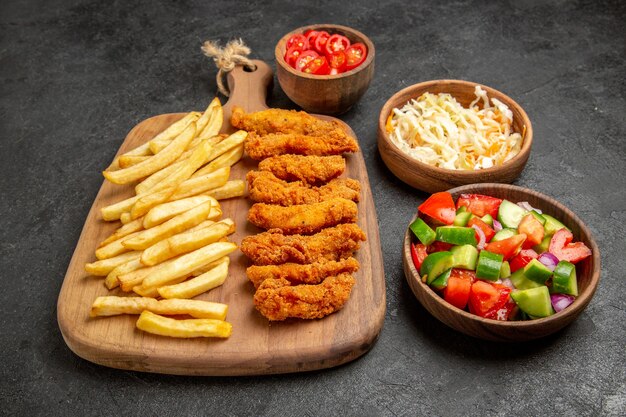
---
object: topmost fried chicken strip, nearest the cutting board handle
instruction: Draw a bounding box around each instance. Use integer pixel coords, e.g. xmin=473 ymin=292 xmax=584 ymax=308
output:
xmin=230 ymin=107 xmax=346 ymax=136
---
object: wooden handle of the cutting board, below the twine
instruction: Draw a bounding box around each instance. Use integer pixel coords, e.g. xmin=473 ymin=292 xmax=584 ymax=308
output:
xmin=224 ymin=59 xmax=274 ymax=120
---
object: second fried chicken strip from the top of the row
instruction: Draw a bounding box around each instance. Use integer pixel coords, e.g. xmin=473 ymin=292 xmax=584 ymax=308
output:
xmin=244 ymin=133 xmax=359 ymax=160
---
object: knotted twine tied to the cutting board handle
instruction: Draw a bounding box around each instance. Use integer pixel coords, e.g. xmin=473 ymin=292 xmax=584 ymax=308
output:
xmin=201 ymin=39 xmax=256 ymax=97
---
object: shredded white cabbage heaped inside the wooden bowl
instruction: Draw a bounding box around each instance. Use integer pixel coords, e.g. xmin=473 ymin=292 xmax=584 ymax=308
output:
xmin=387 ymin=86 xmax=522 ymax=170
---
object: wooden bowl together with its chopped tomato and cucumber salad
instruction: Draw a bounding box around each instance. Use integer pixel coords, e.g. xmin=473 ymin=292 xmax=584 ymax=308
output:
xmin=403 ymin=183 xmax=600 ymax=342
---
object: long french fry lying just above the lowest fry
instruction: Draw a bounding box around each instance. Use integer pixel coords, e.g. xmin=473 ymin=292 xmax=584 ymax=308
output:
xmin=89 ymin=296 xmax=228 ymax=320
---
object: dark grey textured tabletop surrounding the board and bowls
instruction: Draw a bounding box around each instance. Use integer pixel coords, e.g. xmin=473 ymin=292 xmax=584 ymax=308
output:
xmin=0 ymin=0 xmax=626 ymax=416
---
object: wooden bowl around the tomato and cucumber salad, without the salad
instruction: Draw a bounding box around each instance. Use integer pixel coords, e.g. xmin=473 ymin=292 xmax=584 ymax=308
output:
xmin=403 ymin=184 xmax=600 ymax=342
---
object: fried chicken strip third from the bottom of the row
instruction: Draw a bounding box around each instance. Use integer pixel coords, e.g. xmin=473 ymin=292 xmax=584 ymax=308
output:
xmin=241 ymin=223 xmax=367 ymax=265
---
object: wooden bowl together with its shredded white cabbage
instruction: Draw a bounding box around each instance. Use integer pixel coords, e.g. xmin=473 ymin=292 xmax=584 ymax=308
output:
xmin=378 ymin=80 xmax=532 ymax=193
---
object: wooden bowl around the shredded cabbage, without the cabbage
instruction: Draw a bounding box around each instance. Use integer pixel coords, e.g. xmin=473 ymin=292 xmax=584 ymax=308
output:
xmin=378 ymin=80 xmax=533 ymax=193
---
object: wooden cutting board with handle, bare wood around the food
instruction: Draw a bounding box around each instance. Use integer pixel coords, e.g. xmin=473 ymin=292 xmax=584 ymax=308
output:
xmin=57 ymin=61 xmax=385 ymax=375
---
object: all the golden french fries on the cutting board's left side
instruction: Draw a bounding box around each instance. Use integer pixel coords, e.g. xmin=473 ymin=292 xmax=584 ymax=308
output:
xmin=85 ymin=98 xmax=247 ymax=337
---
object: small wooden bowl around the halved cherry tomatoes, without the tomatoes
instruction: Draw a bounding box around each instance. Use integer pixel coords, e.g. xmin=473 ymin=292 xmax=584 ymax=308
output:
xmin=275 ymin=24 xmax=376 ymax=114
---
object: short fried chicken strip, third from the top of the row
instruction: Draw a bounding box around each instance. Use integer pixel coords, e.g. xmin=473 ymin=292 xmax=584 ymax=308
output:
xmin=259 ymin=154 xmax=346 ymax=185
